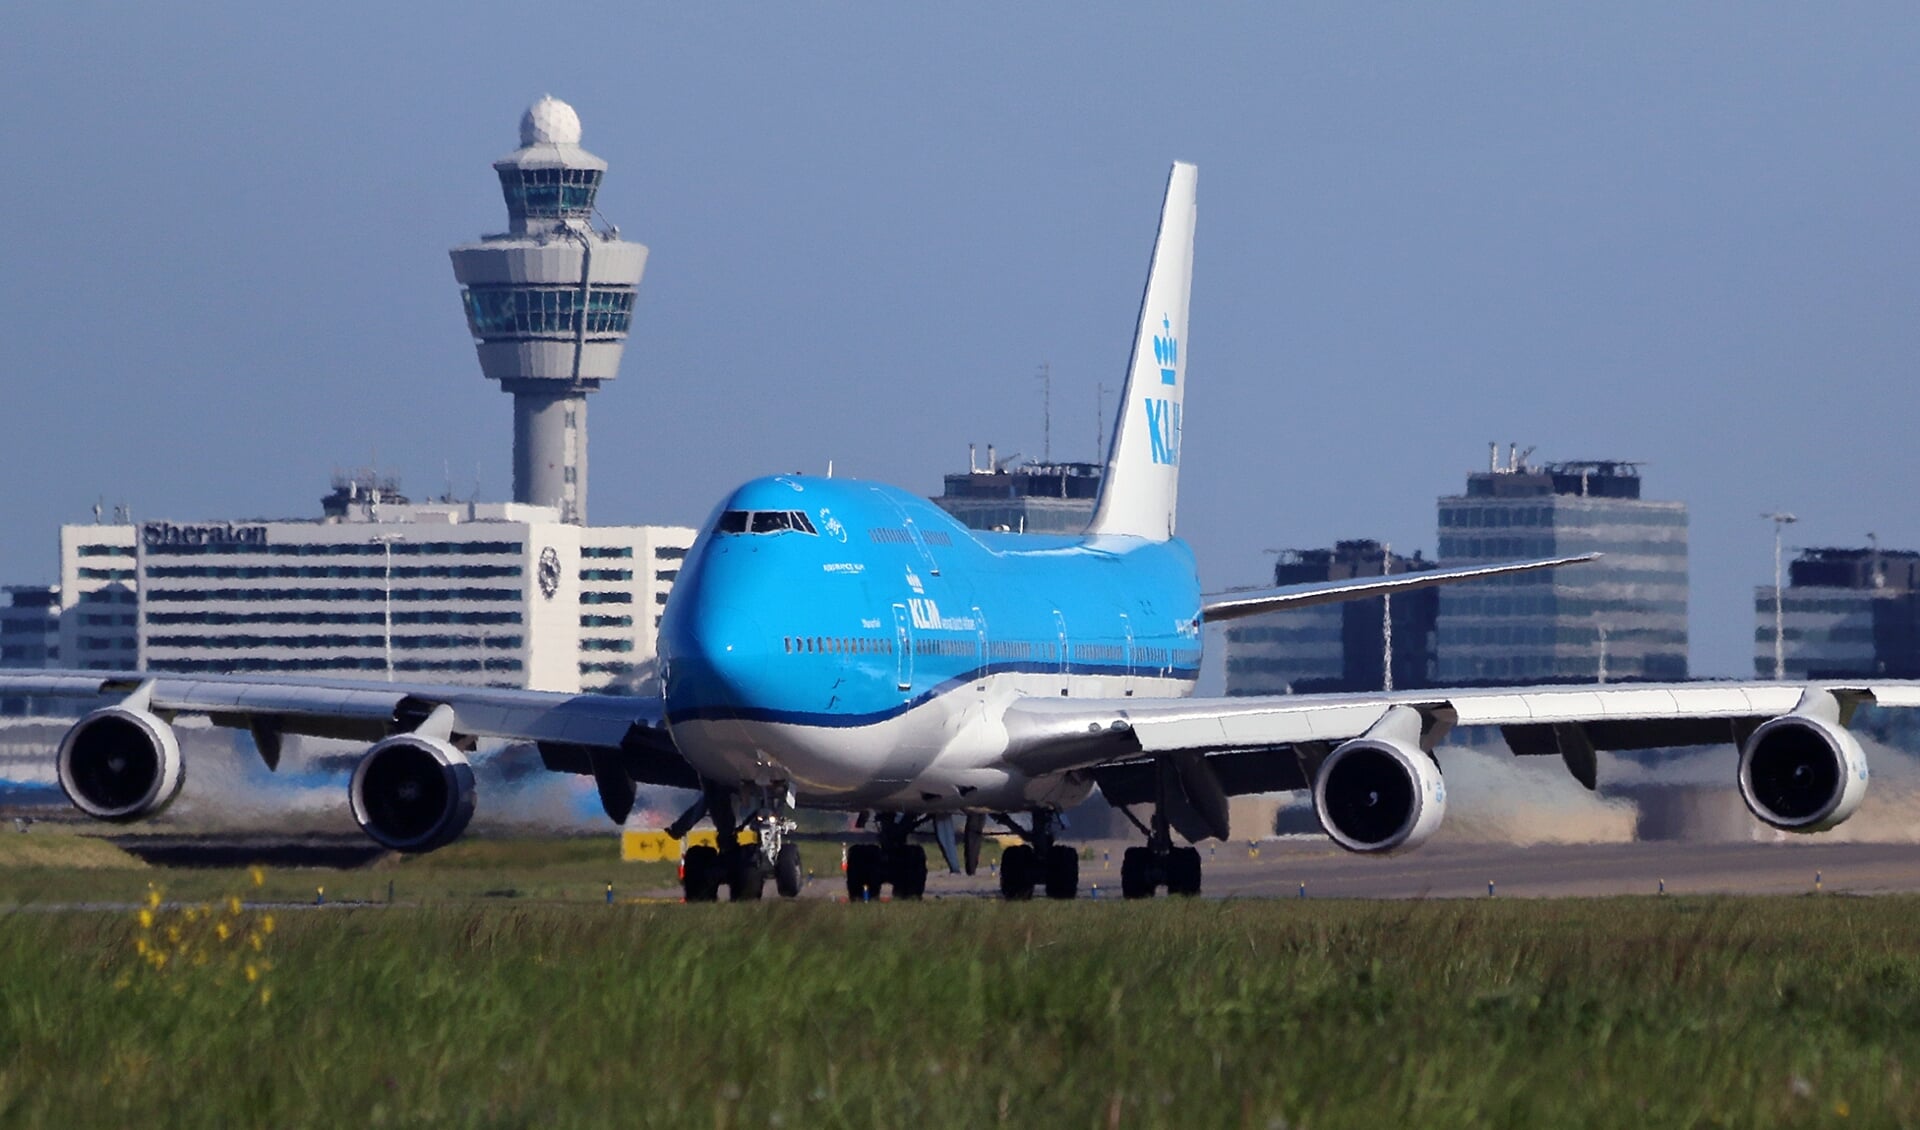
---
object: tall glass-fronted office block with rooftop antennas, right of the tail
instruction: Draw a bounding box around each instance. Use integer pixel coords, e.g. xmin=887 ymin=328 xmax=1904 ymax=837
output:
xmin=1436 ymin=460 xmax=1688 ymax=685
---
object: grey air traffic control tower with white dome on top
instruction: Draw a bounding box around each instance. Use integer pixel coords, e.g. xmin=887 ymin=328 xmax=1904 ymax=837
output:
xmin=451 ymin=96 xmax=647 ymax=526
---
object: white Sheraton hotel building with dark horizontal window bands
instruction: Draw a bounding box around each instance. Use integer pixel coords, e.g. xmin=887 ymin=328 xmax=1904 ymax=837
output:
xmin=61 ymin=476 xmax=695 ymax=693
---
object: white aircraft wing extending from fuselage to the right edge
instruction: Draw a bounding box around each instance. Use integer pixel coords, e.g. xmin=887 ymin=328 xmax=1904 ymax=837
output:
xmin=1006 ymin=679 xmax=1920 ymax=838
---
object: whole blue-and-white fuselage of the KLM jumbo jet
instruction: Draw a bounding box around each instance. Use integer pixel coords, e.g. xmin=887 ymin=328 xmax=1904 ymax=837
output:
xmin=660 ymin=476 xmax=1200 ymax=808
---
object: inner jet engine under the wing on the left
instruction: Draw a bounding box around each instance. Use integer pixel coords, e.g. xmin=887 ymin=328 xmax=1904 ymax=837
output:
xmin=348 ymin=733 xmax=474 ymax=852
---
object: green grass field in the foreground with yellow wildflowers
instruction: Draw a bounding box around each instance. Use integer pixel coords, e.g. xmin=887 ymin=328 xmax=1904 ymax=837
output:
xmin=0 ymin=832 xmax=1920 ymax=1128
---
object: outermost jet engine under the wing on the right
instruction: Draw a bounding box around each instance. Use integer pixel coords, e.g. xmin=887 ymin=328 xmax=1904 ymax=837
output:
xmin=1740 ymin=714 xmax=1868 ymax=833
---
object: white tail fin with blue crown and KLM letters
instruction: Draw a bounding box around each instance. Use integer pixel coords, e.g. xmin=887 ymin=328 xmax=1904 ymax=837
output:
xmin=1087 ymin=161 xmax=1200 ymax=541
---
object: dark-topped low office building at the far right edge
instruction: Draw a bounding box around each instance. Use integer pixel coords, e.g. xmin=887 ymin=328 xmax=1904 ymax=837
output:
xmin=1753 ymin=547 xmax=1920 ymax=679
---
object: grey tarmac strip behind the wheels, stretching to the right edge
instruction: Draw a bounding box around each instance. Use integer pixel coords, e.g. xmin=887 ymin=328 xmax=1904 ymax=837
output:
xmin=898 ymin=840 xmax=1920 ymax=898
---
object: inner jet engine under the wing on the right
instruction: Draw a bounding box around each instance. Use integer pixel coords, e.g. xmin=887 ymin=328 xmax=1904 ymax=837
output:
xmin=1313 ymin=737 xmax=1446 ymax=852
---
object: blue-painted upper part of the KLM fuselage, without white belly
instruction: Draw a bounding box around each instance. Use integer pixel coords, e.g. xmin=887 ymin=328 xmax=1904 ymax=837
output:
xmin=660 ymin=476 xmax=1200 ymax=725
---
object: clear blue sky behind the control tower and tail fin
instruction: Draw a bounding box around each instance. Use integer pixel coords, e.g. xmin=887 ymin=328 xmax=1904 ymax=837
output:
xmin=0 ymin=4 xmax=1920 ymax=675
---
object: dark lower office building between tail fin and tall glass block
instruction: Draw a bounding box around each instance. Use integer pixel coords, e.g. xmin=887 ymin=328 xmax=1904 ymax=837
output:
xmin=1227 ymin=541 xmax=1438 ymax=694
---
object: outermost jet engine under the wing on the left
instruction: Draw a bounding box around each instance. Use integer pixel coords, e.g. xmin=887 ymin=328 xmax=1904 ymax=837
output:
xmin=58 ymin=706 xmax=186 ymax=823
